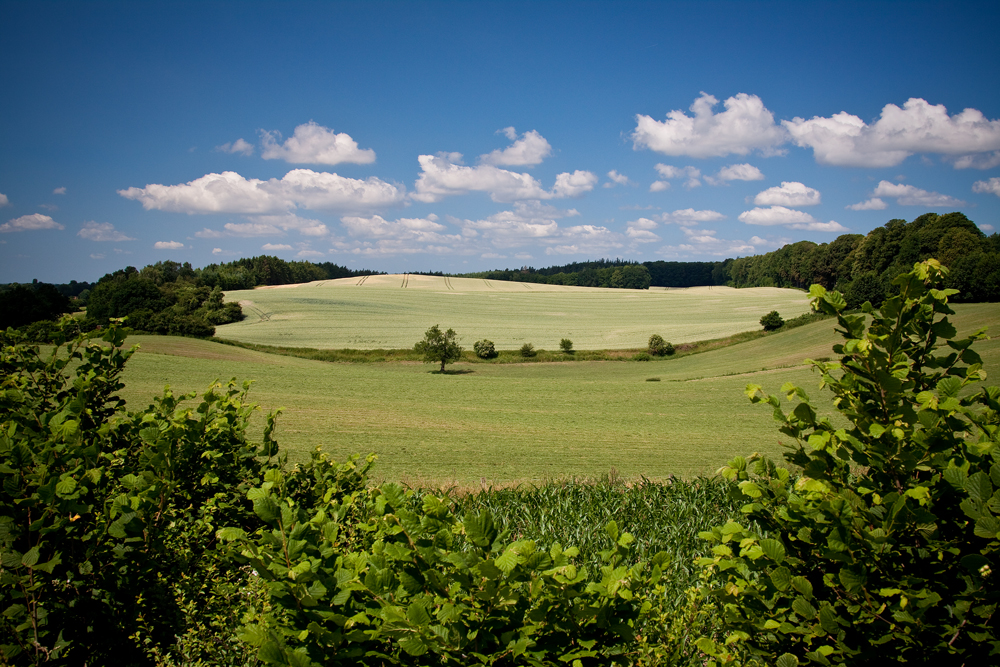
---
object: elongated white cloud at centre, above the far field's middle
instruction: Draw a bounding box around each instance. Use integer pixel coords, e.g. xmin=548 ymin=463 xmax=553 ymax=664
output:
xmin=410 ymin=153 xmax=597 ymax=203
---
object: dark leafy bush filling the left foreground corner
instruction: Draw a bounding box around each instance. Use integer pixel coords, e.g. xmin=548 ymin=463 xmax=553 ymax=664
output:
xmin=0 ymin=327 xmax=276 ymax=664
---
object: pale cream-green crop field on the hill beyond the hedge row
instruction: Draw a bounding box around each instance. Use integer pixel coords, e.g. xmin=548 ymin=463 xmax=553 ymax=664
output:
xmin=216 ymin=275 xmax=809 ymax=350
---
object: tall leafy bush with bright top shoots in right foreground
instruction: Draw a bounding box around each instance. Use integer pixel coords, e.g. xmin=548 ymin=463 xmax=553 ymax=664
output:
xmin=699 ymin=260 xmax=1000 ymax=665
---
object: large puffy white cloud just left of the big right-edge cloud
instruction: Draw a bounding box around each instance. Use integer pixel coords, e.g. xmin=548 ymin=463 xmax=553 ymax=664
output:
xmin=632 ymin=92 xmax=786 ymax=158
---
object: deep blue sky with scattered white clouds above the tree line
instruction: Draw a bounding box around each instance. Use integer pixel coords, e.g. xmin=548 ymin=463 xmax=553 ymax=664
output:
xmin=0 ymin=1 xmax=1000 ymax=282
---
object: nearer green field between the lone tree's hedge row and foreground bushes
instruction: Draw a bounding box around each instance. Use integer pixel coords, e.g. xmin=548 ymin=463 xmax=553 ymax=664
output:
xmin=119 ymin=302 xmax=1000 ymax=487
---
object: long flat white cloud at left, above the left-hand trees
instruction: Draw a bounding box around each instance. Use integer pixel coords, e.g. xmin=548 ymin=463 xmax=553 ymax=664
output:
xmin=118 ymin=169 xmax=405 ymax=214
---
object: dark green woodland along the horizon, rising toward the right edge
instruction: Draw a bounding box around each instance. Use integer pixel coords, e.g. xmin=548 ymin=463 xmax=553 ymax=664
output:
xmin=462 ymin=212 xmax=1000 ymax=308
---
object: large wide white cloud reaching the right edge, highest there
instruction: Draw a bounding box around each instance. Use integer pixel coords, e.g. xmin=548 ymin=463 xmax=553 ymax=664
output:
xmin=782 ymin=97 xmax=1000 ymax=168
